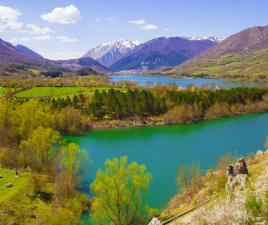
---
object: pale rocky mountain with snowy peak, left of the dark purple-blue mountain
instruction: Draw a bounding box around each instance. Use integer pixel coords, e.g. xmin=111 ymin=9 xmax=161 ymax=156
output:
xmin=83 ymin=40 xmax=140 ymax=67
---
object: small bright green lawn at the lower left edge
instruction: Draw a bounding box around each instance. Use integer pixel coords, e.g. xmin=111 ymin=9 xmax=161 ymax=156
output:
xmin=0 ymin=168 xmax=29 ymax=203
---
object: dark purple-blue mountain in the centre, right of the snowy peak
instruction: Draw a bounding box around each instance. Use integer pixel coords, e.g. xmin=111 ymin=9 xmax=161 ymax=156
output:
xmin=110 ymin=37 xmax=216 ymax=71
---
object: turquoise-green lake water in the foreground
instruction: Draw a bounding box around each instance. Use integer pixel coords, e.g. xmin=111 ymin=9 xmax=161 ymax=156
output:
xmin=68 ymin=114 xmax=268 ymax=212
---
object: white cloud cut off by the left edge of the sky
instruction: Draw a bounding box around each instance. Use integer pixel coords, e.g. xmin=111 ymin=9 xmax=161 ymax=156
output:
xmin=0 ymin=5 xmax=23 ymax=32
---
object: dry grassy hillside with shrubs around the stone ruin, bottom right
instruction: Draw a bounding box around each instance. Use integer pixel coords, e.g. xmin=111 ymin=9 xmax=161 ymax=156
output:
xmin=161 ymin=153 xmax=268 ymax=225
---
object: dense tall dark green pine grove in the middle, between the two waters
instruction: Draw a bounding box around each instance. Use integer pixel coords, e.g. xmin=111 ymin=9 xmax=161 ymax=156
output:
xmin=89 ymin=89 xmax=166 ymax=119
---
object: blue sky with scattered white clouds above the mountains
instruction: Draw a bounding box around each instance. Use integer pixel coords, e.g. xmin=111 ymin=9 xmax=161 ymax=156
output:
xmin=0 ymin=0 xmax=268 ymax=59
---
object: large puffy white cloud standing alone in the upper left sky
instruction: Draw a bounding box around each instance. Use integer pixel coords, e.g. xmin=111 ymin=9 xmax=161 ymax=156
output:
xmin=41 ymin=5 xmax=81 ymax=24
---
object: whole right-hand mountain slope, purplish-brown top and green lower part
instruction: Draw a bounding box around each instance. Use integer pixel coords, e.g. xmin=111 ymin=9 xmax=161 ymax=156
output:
xmin=171 ymin=26 xmax=268 ymax=79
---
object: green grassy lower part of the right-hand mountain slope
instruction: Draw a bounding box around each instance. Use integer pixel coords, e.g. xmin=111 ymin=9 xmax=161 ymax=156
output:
xmin=172 ymin=49 xmax=268 ymax=80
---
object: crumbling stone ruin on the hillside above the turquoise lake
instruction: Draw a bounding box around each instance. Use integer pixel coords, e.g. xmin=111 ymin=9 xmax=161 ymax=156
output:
xmin=226 ymin=158 xmax=248 ymax=192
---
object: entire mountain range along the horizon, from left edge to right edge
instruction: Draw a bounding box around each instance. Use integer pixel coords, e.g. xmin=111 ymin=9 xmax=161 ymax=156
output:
xmin=0 ymin=26 xmax=268 ymax=79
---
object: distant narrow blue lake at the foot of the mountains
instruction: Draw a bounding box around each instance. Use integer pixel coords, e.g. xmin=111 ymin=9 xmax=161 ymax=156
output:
xmin=109 ymin=74 xmax=268 ymax=88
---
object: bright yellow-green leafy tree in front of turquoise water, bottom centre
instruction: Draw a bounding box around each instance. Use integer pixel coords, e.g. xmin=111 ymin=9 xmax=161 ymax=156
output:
xmin=91 ymin=157 xmax=152 ymax=225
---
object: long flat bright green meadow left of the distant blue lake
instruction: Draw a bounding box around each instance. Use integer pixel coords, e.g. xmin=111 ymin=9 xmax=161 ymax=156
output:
xmin=15 ymin=87 xmax=123 ymax=98
